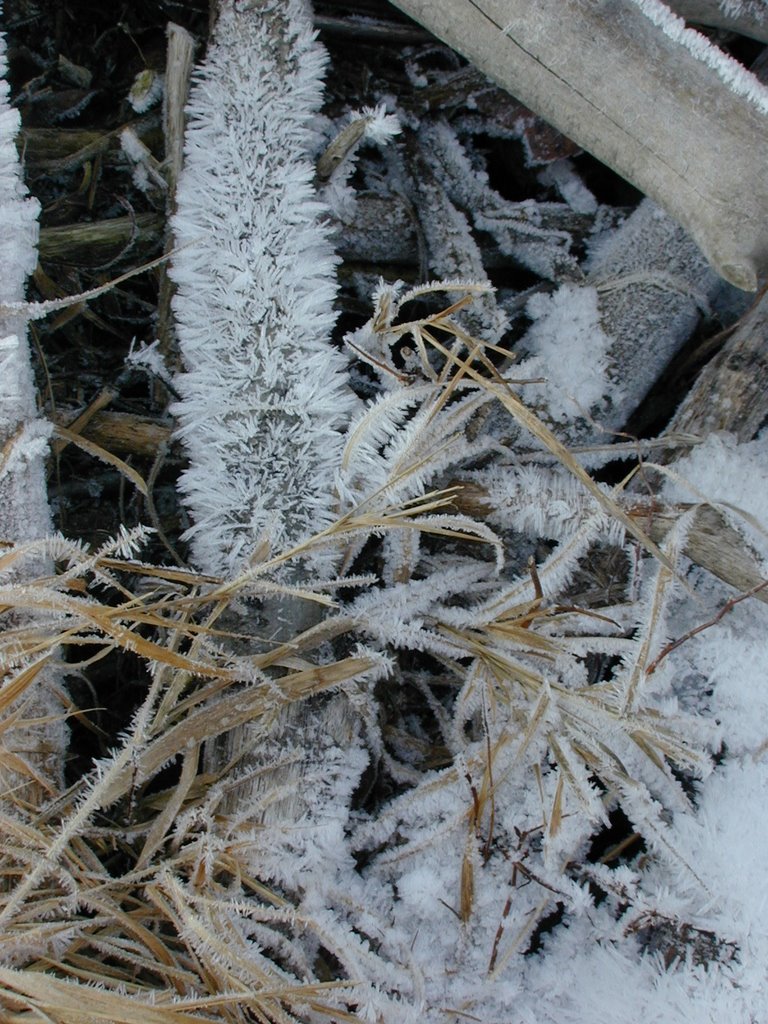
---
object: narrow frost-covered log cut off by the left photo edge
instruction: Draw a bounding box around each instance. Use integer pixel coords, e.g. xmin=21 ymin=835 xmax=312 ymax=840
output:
xmin=0 ymin=29 xmax=65 ymax=806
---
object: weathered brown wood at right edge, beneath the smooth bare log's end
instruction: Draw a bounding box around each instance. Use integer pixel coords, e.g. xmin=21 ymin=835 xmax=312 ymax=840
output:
xmin=665 ymin=291 xmax=768 ymax=442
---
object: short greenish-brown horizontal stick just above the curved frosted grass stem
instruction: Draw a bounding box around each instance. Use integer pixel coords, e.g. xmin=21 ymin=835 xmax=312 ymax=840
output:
xmin=38 ymin=213 xmax=165 ymax=267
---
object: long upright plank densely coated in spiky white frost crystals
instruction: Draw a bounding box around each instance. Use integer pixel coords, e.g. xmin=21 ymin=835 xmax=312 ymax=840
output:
xmin=171 ymin=2 xmax=355 ymax=572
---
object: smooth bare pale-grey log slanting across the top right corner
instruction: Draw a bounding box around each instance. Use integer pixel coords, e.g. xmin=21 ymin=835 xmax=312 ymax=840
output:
xmin=395 ymin=0 xmax=768 ymax=291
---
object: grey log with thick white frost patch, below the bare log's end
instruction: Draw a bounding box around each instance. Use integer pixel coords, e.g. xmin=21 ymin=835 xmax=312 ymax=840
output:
xmin=523 ymin=200 xmax=738 ymax=444
